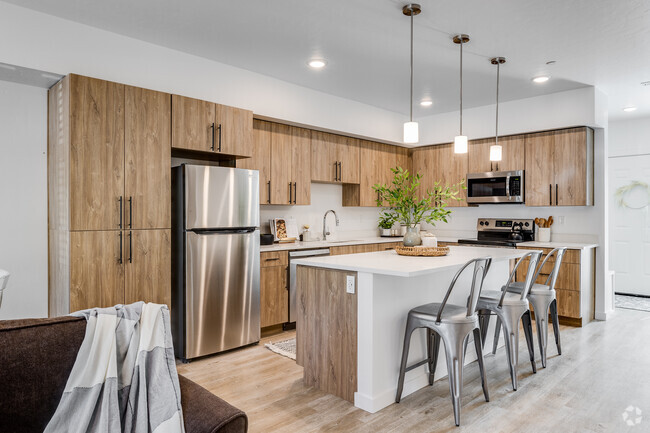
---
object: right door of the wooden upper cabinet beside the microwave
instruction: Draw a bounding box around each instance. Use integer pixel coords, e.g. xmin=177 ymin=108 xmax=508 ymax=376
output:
xmin=553 ymin=128 xmax=591 ymax=206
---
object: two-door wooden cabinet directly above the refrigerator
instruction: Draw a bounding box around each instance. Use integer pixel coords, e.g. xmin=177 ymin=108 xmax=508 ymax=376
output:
xmin=172 ymin=95 xmax=253 ymax=157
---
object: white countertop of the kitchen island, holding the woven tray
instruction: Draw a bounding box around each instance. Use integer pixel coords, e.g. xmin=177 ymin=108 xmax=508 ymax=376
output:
xmin=292 ymin=246 xmax=527 ymax=277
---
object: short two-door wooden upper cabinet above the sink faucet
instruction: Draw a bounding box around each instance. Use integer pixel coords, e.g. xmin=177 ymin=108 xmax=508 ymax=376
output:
xmin=311 ymin=131 xmax=359 ymax=183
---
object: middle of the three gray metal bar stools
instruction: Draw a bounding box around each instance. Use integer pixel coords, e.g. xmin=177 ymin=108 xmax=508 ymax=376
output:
xmin=477 ymin=251 xmax=542 ymax=391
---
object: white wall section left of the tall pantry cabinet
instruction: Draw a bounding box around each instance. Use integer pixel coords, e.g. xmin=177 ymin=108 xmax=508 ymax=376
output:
xmin=0 ymin=81 xmax=47 ymax=319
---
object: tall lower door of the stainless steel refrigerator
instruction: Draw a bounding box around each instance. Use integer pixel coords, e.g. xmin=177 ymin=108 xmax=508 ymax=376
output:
xmin=184 ymin=229 xmax=260 ymax=359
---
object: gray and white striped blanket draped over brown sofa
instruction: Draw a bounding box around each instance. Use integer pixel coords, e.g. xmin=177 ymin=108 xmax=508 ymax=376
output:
xmin=45 ymin=302 xmax=185 ymax=433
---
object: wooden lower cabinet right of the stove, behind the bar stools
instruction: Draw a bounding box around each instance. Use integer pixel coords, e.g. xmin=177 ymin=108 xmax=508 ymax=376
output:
xmin=517 ymin=248 xmax=595 ymax=326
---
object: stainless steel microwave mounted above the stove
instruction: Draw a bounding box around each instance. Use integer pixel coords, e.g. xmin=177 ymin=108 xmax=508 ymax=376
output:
xmin=467 ymin=170 xmax=524 ymax=204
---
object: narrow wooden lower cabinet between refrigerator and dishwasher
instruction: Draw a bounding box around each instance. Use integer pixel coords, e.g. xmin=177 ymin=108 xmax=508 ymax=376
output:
xmin=260 ymin=251 xmax=289 ymax=328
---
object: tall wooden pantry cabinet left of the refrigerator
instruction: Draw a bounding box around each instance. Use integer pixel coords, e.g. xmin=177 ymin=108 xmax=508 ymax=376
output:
xmin=48 ymin=75 xmax=171 ymax=316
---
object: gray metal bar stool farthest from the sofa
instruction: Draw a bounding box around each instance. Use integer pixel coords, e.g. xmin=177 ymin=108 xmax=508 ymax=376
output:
xmin=492 ymin=247 xmax=566 ymax=368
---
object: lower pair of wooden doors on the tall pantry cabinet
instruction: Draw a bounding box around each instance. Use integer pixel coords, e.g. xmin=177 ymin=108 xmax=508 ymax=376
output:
xmin=63 ymin=229 xmax=171 ymax=316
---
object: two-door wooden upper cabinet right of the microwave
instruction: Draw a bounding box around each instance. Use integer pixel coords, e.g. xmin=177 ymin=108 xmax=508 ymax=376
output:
xmin=525 ymin=127 xmax=594 ymax=206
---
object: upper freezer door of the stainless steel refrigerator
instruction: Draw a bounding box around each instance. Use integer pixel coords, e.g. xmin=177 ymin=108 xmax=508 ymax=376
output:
xmin=184 ymin=165 xmax=260 ymax=230
